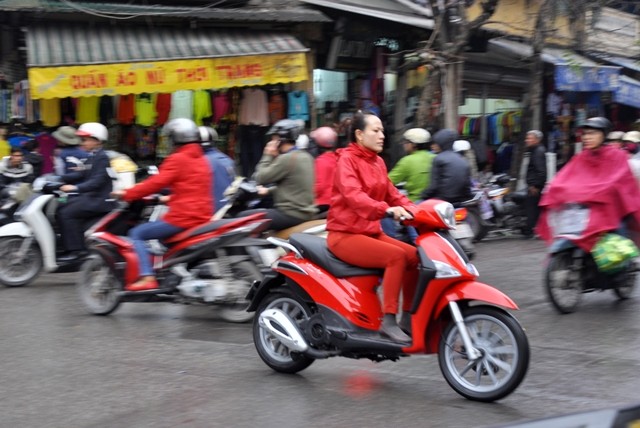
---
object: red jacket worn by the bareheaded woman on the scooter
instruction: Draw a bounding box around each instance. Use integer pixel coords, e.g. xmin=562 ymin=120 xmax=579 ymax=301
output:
xmin=327 ymin=143 xmax=414 ymax=235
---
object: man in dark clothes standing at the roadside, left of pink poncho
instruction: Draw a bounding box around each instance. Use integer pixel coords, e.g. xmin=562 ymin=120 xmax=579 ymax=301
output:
xmin=523 ymin=130 xmax=547 ymax=239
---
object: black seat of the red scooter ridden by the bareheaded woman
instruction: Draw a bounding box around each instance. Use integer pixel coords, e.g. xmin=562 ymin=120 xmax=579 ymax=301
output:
xmin=289 ymin=233 xmax=384 ymax=278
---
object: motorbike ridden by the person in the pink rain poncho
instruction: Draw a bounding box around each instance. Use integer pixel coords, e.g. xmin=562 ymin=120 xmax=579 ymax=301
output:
xmin=545 ymin=204 xmax=638 ymax=314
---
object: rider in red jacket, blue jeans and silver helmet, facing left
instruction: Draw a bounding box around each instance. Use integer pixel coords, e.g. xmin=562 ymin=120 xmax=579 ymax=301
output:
xmin=113 ymin=119 xmax=213 ymax=291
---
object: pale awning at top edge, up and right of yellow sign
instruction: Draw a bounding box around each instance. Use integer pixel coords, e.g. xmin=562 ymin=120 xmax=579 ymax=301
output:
xmin=301 ymin=0 xmax=433 ymax=30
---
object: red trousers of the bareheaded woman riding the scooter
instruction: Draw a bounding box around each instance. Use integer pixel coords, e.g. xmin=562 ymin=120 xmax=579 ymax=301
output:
xmin=327 ymin=232 xmax=418 ymax=314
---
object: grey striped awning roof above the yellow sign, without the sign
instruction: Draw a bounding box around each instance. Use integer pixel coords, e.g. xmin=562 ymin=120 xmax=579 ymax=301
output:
xmin=27 ymin=25 xmax=309 ymax=67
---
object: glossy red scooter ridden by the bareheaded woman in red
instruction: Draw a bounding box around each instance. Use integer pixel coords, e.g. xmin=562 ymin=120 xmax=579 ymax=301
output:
xmin=247 ymin=200 xmax=529 ymax=402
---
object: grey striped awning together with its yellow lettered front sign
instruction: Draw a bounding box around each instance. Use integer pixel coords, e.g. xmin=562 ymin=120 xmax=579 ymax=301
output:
xmin=27 ymin=26 xmax=308 ymax=99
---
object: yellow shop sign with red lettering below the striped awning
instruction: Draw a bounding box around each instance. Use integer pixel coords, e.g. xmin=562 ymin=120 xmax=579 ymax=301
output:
xmin=28 ymin=53 xmax=308 ymax=99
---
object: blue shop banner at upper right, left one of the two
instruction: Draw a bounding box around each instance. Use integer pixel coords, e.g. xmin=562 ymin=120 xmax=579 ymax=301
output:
xmin=555 ymin=65 xmax=620 ymax=92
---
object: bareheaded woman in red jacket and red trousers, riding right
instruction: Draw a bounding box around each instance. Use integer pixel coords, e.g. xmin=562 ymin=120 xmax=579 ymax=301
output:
xmin=327 ymin=112 xmax=418 ymax=342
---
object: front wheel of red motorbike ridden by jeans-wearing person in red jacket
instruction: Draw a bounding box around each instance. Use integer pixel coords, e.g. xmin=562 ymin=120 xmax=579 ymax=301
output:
xmin=76 ymin=254 xmax=122 ymax=315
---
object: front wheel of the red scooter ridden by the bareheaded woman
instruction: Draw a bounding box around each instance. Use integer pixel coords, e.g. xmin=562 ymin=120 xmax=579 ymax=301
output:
xmin=438 ymin=306 xmax=529 ymax=402
